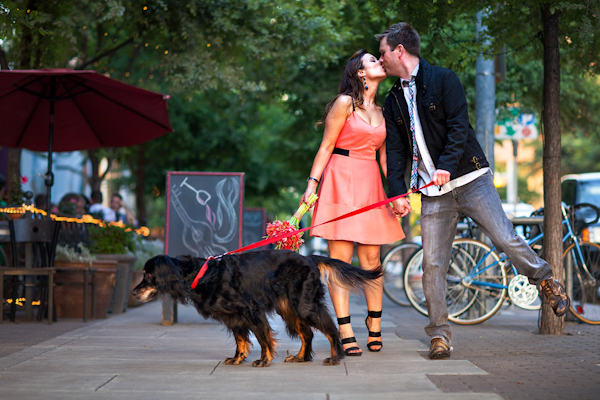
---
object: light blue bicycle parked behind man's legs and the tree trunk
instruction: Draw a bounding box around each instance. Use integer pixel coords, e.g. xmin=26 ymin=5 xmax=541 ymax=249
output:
xmin=404 ymin=204 xmax=600 ymax=325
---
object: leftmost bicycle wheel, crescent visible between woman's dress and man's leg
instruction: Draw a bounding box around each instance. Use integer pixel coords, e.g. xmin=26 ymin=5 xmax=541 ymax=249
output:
xmin=381 ymin=242 xmax=421 ymax=307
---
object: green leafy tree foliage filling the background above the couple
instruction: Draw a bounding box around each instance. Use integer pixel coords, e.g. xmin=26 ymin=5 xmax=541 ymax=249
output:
xmin=0 ymin=0 xmax=600 ymax=225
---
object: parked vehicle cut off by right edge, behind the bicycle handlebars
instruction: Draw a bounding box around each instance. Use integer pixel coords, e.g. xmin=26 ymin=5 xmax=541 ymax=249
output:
xmin=561 ymin=172 xmax=600 ymax=243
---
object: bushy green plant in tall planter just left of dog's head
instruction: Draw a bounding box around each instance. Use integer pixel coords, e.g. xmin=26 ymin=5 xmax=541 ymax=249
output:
xmin=87 ymin=225 xmax=136 ymax=314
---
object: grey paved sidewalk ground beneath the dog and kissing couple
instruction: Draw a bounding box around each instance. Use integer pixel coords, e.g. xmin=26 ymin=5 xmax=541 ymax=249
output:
xmin=0 ymin=297 xmax=600 ymax=400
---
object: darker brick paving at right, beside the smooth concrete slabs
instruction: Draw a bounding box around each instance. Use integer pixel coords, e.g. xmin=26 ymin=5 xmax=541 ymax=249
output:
xmin=384 ymin=298 xmax=600 ymax=400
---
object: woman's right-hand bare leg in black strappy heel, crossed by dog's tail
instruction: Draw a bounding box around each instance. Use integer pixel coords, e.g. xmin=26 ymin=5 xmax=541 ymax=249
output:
xmin=357 ymin=244 xmax=383 ymax=351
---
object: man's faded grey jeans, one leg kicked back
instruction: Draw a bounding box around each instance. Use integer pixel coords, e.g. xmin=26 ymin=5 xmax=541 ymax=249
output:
xmin=421 ymin=172 xmax=552 ymax=345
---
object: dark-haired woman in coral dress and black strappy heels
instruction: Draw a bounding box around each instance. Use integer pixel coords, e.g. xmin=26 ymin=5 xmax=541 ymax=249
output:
xmin=301 ymin=50 xmax=404 ymax=356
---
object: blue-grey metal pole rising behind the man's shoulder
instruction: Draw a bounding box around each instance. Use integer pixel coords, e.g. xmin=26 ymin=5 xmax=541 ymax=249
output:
xmin=475 ymin=11 xmax=496 ymax=172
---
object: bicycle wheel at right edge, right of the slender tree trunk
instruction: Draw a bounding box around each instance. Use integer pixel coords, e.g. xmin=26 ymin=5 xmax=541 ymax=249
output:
xmin=563 ymin=242 xmax=600 ymax=325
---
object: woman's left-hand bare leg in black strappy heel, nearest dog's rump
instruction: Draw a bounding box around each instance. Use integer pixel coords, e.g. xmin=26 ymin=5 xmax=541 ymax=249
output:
xmin=327 ymin=240 xmax=362 ymax=353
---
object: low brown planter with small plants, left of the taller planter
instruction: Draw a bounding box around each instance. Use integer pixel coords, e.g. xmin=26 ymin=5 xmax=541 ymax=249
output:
xmin=54 ymin=243 xmax=117 ymax=318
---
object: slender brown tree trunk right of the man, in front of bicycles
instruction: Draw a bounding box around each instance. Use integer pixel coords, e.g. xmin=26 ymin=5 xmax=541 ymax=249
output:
xmin=540 ymin=4 xmax=565 ymax=335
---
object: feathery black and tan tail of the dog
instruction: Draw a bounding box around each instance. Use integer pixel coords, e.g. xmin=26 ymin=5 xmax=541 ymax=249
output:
xmin=308 ymin=255 xmax=383 ymax=292
